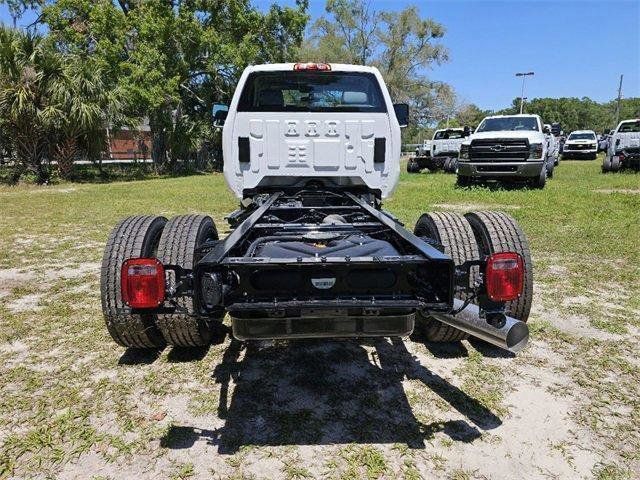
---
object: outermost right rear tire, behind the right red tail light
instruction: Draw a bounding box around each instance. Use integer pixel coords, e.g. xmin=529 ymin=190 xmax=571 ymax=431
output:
xmin=465 ymin=212 xmax=533 ymax=322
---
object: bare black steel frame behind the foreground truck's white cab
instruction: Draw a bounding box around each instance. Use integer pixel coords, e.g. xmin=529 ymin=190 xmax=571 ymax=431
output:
xmin=151 ymin=190 xmax=464 ymax=318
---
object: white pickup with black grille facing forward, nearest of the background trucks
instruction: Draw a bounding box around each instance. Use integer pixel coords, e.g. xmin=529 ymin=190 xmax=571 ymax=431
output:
xmin=458 ymin=115 xmax=554 ymax=188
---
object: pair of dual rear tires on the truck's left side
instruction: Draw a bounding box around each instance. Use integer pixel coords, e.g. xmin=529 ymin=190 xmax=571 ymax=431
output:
xmin=100 ymin=215 xmax=222 ymax=348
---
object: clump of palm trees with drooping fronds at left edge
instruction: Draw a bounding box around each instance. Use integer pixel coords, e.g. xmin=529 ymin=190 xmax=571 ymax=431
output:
xmin=0 ymin=27 xmax=124 ymax=183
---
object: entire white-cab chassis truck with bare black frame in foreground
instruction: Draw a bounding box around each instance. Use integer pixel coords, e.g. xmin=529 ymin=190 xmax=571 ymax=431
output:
xmin=101 ymin=63 xmax=533 ymax=351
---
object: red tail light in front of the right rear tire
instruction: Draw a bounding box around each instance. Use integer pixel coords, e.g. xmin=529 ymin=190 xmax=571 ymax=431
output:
xmin=485 ymin=252 xmax=524 ymax=302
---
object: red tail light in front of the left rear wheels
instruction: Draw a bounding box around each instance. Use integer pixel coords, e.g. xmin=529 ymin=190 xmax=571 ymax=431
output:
xmin=120 ymin=258 xmax=164 ymax=308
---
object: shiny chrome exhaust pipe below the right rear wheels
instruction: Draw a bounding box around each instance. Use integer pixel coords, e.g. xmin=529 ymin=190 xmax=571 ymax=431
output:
xmin=429 ymin=298 xmax=529 ymax=353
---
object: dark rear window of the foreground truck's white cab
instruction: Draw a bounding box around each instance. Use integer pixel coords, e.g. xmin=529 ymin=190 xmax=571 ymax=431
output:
xmin=238 ymin=71 xmax=387 ymax=113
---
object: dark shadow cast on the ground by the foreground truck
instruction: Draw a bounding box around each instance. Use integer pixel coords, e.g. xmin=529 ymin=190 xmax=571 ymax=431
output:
xmin=161 ymin=339 xmax=502 ymax=454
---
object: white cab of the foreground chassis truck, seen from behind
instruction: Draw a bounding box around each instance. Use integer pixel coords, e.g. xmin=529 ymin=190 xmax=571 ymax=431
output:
xmin=222 ymin=63 xmax=408 ymax=198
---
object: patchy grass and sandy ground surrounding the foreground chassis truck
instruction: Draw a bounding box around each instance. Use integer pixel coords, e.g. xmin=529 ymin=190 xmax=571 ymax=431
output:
xmin=0 ymin=160 xmax=640 ymax=479
